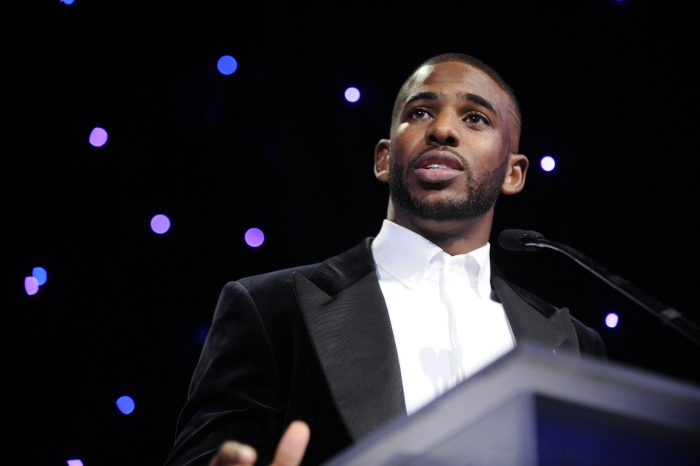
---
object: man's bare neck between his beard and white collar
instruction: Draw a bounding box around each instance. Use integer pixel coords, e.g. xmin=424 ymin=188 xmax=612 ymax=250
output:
xmin=387 ymin=203 xmax=493 ymax=256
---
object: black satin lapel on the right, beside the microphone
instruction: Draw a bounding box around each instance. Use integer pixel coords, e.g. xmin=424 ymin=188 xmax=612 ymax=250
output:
xmin=491 ymin=274 xmax=579 ymax=353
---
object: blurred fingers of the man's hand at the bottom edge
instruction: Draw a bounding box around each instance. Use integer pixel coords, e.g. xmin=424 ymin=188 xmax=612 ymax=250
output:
xmin=209 ymin=421 xmax=310 ymax=466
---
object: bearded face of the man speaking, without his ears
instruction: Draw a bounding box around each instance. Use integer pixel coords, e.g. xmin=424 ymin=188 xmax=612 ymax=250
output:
xmin=389 ymin=62 xmax=514 ymax=220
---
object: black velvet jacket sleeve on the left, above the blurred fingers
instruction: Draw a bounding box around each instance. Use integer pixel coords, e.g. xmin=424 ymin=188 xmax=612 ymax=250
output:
xmin=165 ymin=282 xmax=284 ymax=466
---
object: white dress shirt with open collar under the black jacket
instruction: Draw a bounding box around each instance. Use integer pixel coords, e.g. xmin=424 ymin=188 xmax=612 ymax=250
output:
xmin=372 ymin=220 xmax=515 ymax=414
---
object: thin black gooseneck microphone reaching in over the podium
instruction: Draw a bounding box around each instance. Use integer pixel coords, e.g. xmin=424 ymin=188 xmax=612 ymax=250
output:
xmin=498 ymin=228 xmax=700 ymax=346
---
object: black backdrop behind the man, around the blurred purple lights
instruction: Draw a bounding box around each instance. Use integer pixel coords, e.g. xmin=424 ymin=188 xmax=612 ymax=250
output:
xmin=2 ymin=0 xmax=700 ymax=466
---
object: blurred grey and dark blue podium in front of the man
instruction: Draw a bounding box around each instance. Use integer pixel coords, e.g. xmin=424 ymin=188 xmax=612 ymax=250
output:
xmin=325 ymin=344 xmax=700 ymax=466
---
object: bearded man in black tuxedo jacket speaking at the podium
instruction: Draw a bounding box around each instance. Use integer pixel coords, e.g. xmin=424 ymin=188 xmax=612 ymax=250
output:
xmin=167 ymin=54 xmax=605 ymax=466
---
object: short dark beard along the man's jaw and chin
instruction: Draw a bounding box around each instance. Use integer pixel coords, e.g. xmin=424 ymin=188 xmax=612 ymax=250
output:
xmin=389 ymin=157 xmax=508 ymax=221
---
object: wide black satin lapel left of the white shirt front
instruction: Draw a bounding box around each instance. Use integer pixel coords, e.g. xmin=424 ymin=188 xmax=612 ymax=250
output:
xmin=294 ymin=242 xmax=406 ymax=440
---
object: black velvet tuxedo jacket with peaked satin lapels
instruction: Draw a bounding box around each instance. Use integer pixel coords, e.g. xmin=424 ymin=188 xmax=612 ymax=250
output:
xmin=166 ymin=238 xmax=605 ymax=466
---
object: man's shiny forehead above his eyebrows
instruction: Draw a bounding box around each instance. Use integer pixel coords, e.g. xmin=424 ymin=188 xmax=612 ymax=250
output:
xmin=402 ymin=61 xmax=510 ymax=113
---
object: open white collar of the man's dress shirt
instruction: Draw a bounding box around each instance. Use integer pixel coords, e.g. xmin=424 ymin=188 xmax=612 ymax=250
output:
xmin=372 ymin=219 xmax=491 ymax=299
